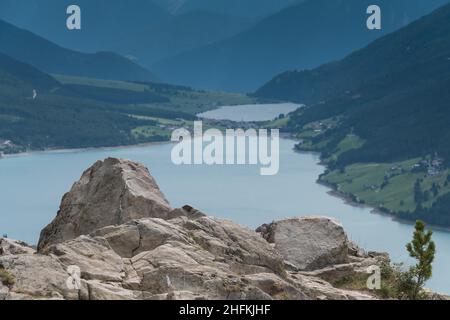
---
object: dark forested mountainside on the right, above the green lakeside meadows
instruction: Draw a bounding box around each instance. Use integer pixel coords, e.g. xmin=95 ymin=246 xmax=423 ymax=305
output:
xmin=256 ymin=1 xmax=450 ymax=162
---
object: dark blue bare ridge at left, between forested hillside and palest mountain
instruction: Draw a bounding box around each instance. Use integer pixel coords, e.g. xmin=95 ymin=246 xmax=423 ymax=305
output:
xmin=0 ymin=20 xmax=156 ymax=81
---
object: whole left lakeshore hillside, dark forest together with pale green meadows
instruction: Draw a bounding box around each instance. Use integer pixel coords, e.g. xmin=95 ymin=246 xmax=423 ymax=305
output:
xmin=0 ymin=53 xmax=252 ymax=155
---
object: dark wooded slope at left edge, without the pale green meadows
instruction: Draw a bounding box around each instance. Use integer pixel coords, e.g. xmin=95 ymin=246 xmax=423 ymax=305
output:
xmin=0 ymin=54 xmax=151 ymax=152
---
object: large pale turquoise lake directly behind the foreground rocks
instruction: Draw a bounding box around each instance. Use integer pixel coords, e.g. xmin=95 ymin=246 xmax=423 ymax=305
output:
xmin=0 ymin=104 xmax=450 ymax=293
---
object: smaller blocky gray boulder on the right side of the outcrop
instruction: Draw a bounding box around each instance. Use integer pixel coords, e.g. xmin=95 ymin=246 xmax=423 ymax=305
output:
xmin=257 ymin=217 xmax=349 ymax=270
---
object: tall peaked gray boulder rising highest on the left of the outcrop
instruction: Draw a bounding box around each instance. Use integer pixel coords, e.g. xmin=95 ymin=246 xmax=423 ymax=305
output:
xmin=38 ymin=158 xmax=171 ymax=251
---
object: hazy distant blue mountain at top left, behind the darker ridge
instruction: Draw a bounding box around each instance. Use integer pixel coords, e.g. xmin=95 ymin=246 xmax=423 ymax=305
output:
xmin=0 ymin=0 xmax=253 ymax=67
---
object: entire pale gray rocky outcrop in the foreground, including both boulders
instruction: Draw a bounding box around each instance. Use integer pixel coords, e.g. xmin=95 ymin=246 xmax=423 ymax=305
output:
xmin=0 ymin=159 xmax=386 ymax=300
